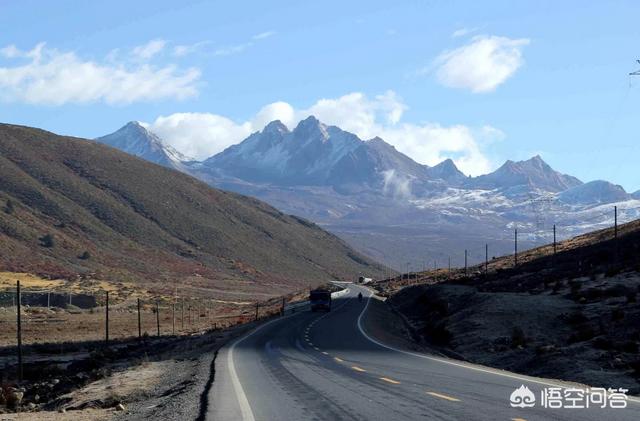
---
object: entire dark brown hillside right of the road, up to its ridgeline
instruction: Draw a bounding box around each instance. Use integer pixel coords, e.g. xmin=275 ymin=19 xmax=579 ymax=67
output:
xmin=378 ymin=221 xmax=640 ymax=394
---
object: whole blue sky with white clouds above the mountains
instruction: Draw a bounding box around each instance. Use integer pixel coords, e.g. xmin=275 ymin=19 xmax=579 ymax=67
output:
xmin=0 ymin=0 xmax=640 ymax=191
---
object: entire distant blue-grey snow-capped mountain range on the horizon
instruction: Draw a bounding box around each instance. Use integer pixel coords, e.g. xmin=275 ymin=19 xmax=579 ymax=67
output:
xmin=99 ymin=117 xmax=640 ymax=268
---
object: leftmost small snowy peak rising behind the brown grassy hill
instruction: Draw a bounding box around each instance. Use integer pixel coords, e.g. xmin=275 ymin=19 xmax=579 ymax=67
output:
xmin=95 ymin=121 xmax=192 ymax=171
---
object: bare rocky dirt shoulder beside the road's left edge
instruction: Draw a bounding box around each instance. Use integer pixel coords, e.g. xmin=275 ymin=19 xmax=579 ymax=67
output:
xmin=0 ymin=314 xmax=255 ymax=420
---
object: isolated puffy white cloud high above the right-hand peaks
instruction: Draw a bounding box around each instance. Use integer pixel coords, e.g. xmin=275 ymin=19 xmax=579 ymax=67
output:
xmin=432 ymin=35 xmax=529 ymax=93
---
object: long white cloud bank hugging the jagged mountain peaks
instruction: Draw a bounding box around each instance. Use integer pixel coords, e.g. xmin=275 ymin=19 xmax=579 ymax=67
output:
xmin=148 ymin=91 xmax=504 ymax=174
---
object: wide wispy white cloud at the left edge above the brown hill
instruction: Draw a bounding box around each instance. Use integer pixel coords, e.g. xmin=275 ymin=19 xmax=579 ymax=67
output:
xmin=0 ymin=43 xmax=200 ymax=105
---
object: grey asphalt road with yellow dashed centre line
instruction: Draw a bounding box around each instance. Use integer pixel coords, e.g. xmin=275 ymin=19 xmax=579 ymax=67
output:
xmin=207 ymin=285 xmax=640 ymax=421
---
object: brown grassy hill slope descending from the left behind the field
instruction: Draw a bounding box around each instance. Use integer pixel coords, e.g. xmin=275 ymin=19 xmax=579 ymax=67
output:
xmin=0 ymin=125 xmax=380 ymax=294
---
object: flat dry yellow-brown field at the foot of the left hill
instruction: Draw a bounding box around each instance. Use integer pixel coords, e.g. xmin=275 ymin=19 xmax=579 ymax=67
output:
xmin=0 ymin=284 xmax=284 ymax=347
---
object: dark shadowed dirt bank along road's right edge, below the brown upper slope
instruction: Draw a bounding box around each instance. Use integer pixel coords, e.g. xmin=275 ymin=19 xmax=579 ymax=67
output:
xmin=389 ymin=272 xmax=640 ymax=394
